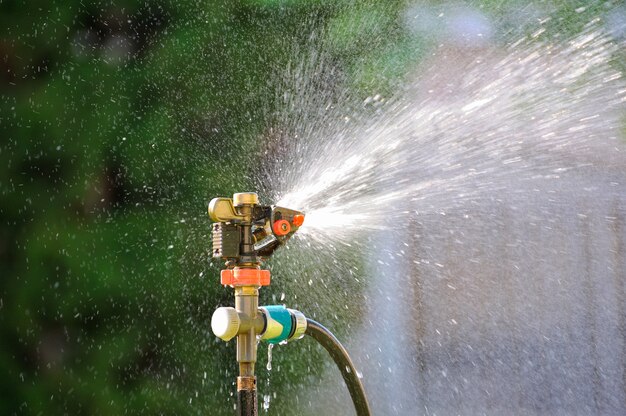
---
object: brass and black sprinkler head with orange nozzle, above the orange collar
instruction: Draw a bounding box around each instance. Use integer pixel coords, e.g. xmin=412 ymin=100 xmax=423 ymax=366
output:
xmin=209 ymin=192 xmax=304 ymax=269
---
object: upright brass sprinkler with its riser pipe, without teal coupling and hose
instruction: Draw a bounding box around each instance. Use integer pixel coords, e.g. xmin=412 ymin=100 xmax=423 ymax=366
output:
xmin=209 ymin=192 xmax=306 ymax=415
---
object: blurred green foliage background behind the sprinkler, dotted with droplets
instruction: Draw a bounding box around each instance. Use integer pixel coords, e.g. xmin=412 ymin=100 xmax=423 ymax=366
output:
xmin=0 ymin=0 xmax=626 ymax=415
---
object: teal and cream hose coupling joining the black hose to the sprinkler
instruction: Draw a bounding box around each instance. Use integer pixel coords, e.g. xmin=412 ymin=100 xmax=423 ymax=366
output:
xmin=259 ymin=305 xmax=306 ymax=344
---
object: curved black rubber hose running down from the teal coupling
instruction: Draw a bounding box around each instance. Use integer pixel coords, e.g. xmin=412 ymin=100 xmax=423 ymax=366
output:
xmin=305 ymin=318 xmax=372 ymax=416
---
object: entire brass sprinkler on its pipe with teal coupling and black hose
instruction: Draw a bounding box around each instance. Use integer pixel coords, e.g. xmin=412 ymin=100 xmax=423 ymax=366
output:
xmin=209 ymin=192 xmax=371 ymax=416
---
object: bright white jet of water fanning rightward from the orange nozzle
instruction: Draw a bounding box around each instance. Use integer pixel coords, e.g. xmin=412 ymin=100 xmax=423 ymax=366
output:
xmin=273 ymin=25 xmax=626 ymax=247
